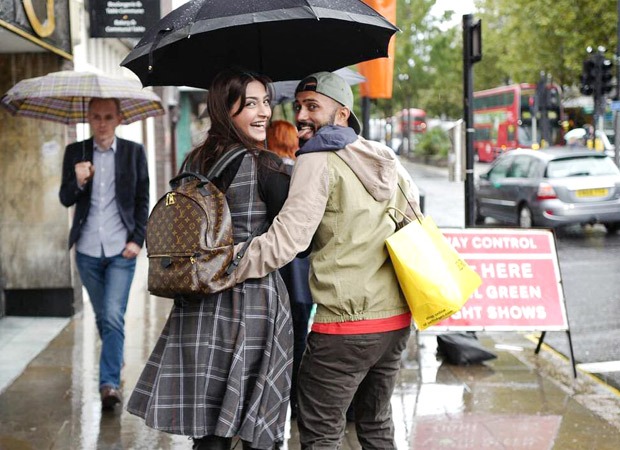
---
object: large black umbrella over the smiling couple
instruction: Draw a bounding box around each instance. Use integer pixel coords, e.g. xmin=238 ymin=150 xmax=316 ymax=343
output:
xmin=121 ymin=0 xmax=398 ymax=88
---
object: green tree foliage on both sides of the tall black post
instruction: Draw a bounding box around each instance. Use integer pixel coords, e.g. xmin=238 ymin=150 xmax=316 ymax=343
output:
xmin=373 ymin=0 xmax=618 ymax=119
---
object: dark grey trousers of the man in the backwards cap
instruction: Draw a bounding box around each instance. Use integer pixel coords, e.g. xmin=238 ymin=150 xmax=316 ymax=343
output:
xmin=297 ymin=327 xmax=410 ymax=450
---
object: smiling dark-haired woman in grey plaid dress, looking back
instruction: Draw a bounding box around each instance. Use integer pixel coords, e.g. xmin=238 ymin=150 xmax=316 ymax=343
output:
xmin=127 ymin=70 xmax=293 ymax=450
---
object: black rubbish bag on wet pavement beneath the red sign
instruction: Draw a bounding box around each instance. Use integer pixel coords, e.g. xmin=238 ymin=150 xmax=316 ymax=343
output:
xmin=437 ymin=333 xmax=497 ymax=366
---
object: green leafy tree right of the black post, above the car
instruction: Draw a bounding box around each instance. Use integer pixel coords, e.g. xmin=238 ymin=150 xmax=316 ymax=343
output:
xmin=474 ymin=0 xmax=617 ymax=90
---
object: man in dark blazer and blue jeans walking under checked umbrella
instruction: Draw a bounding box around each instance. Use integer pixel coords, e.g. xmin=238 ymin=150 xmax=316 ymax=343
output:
xmin=60 ymin=98 xmax=149 ymax=409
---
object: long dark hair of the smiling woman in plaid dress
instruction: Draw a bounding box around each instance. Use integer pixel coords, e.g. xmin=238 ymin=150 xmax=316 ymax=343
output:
xmin=181 ymin=68 xmax=272 ymax=174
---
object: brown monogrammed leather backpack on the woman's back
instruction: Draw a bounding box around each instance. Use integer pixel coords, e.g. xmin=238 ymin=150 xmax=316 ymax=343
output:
xmin=146 ymin=148 xmax=245 ymax=298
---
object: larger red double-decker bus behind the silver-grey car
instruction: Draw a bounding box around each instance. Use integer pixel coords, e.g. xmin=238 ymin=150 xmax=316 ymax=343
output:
xmin=473 ymin=83 xmax=562 ymax=162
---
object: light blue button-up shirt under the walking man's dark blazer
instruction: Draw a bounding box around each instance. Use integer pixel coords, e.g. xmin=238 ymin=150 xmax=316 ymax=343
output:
xmin=76 ymin=138 xmax=128 ymax=258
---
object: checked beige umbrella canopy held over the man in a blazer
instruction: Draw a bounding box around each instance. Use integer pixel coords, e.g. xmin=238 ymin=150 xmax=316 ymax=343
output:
xmin=0 ymin=71 xmax=165 ymax=125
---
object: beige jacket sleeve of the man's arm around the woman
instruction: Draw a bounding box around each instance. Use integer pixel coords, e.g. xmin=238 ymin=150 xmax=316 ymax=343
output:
xmin=234 ymin=152 xmax=329 ymax=283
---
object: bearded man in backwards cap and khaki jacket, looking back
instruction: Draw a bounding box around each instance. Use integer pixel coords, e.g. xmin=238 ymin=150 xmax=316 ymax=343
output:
xmin=235 ymin=72 xmax=419 ymax=449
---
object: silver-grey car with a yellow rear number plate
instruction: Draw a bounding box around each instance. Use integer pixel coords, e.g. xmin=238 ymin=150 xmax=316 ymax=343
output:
xmin=475 ymin=147 xmax=620 ymax=233
